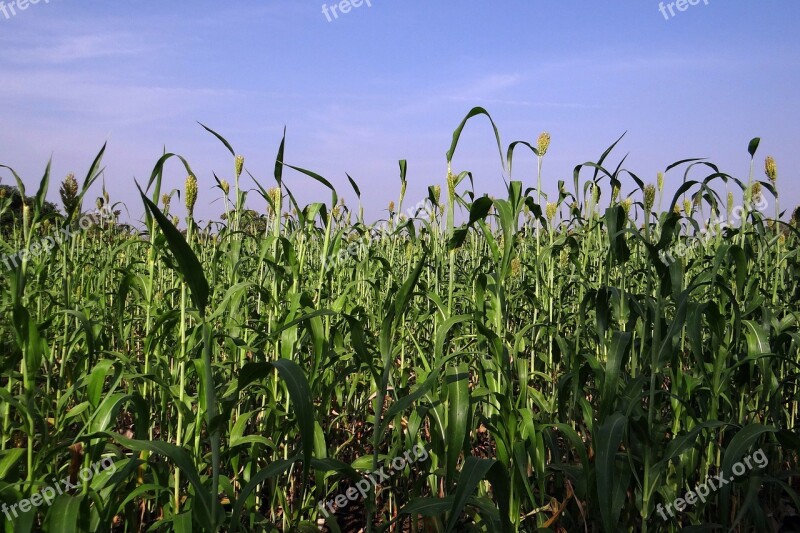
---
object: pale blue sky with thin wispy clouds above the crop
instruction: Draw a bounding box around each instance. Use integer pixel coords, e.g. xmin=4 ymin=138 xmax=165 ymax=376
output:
xmin=0 ymin=0 xmax=800 ymax=219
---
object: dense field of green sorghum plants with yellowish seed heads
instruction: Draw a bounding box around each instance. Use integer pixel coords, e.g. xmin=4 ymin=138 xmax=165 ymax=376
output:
xmin=0 ymin=108 xmax=800 ymax=532
